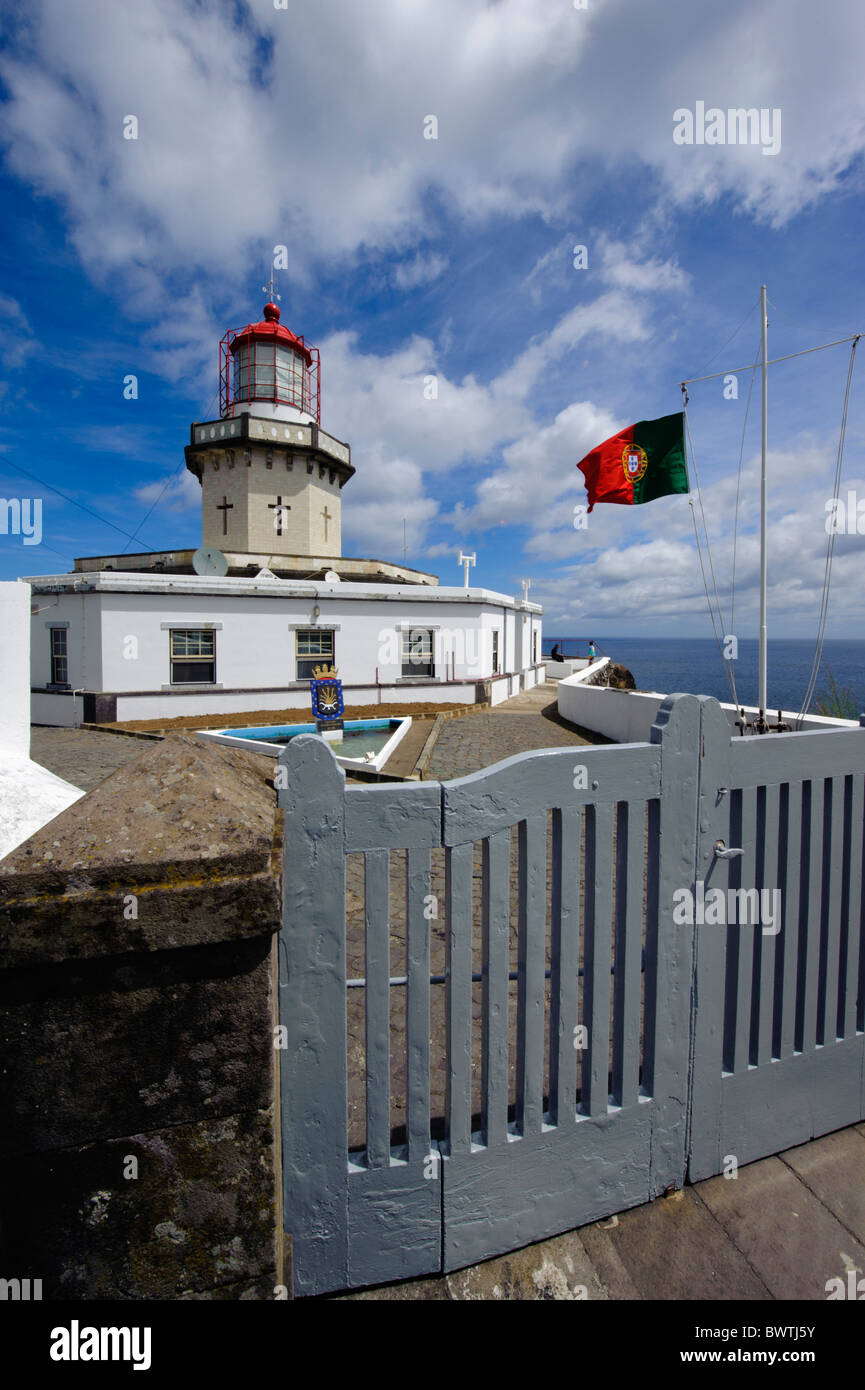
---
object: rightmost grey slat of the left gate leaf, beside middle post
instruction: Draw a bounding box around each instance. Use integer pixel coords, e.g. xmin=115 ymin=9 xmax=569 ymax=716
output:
xmin=613 ymin=802 xmax=644 ymax=1105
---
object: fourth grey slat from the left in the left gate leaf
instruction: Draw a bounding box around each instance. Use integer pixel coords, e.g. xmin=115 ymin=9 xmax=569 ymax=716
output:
xmin=481 ymin=830 xmax=510 ymax=1145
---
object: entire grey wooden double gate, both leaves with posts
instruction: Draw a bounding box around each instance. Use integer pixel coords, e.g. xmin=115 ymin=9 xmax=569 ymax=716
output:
xmin=278 ymin=695 xmax=865 ymax=1294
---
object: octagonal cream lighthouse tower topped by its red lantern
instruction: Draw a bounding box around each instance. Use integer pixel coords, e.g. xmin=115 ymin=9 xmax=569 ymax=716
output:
xmin=186 ymin=291 xmax=355 ymax=558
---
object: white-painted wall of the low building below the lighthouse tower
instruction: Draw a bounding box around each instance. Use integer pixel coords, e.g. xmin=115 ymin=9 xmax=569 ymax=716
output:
xmin=32 ymin=575 xmax=540 ymax=724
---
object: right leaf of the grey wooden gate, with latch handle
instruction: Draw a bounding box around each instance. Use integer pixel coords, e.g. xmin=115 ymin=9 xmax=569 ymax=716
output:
xmin=688 ymin=699 xmax=865 ymax=1180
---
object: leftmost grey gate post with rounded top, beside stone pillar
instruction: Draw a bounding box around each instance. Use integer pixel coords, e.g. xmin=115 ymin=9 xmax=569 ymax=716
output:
xmin=274 ymin=734 xmax=349 ymax=1294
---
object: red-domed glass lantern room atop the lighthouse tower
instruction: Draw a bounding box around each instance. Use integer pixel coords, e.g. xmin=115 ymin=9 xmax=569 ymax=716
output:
xmin=220 ymin=303 xmax=321 ymax=424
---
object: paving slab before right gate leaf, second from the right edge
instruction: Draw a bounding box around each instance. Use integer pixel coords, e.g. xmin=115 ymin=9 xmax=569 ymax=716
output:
xmin=698 ymin=1140 xmax=865 ymax=1298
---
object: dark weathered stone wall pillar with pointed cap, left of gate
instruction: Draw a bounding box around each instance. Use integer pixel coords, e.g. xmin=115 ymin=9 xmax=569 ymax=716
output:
xmin=0 ymin=735 xmax=289 ymax=1300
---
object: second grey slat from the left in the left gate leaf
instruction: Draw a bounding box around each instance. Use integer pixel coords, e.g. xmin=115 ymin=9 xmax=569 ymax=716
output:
xmin=406 ymin=849 xmax=430 ymax=1163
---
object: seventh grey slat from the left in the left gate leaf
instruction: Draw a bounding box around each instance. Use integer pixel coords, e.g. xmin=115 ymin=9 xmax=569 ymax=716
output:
xmin=580 ymin=805 xmax=613 ymax=1116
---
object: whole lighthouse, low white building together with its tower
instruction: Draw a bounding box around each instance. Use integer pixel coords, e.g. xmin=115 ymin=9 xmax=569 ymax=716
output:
xmin=26 ymin=300 xmax=542 ymax=726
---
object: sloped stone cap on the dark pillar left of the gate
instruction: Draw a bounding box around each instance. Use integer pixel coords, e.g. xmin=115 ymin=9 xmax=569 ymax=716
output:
xmin=0 ymin=734 xmax=282 ymax=969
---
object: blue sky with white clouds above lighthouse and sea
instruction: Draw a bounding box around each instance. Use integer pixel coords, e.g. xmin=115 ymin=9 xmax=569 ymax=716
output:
xmin=0 ymin=0 xmax=865 ymax=637
